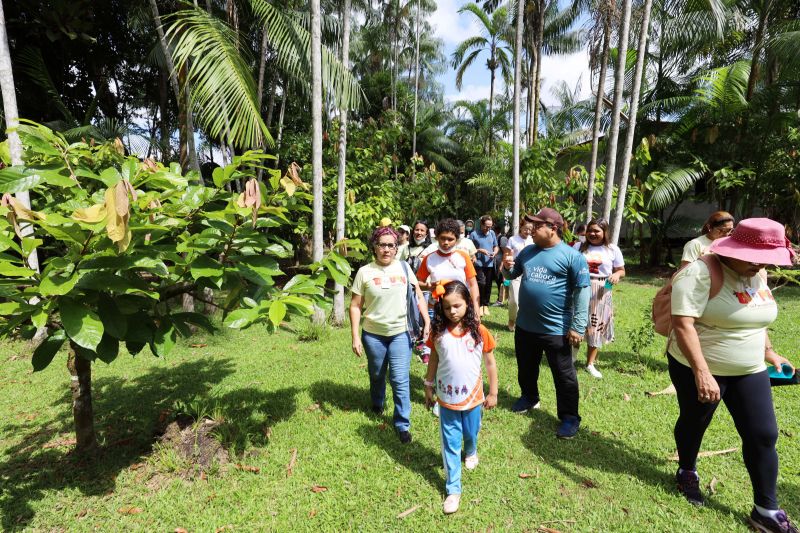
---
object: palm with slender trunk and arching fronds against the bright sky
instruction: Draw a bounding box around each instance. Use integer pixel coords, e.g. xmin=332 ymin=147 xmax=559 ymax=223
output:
xmin=452 ymin=2 xmax=512 ymax=154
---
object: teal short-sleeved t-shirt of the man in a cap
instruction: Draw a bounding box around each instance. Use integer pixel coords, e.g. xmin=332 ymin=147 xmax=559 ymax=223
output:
xmin=511 ymin=242 xmax=589 ymax=335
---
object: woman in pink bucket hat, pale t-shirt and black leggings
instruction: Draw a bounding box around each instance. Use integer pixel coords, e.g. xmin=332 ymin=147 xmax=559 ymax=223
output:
xmin=667 ymin=218 xmax=798 ymax=533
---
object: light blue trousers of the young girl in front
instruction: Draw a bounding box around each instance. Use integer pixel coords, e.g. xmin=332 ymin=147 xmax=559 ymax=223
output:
xmin=439 ymin=405 xmax=481 ymax=495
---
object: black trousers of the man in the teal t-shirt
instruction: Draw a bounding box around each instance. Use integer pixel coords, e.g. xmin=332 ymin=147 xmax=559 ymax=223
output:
xmin=514 ymin=325 xmax=580 ymax=420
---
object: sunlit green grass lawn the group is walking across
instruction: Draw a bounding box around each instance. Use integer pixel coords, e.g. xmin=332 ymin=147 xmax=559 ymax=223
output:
xmin=0 ymin=277 xmax=800 ymax=532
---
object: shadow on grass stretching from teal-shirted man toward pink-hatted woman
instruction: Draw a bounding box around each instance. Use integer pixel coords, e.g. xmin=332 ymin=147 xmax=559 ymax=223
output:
xmin=522 ymin=410 xmax=741 ymax=515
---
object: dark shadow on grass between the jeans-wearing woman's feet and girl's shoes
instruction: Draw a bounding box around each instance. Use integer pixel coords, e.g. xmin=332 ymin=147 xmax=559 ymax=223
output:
xmin=358 ymin=424 xmax=444 ymax=494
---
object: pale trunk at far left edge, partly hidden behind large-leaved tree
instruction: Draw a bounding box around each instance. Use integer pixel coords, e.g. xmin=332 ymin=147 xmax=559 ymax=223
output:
xmin=0 ymin=1 xmax=39 ymax=272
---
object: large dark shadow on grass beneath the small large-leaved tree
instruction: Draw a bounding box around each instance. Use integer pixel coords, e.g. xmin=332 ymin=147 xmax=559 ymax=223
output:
xmin=0 ymin=359 xmax=234 ymax=531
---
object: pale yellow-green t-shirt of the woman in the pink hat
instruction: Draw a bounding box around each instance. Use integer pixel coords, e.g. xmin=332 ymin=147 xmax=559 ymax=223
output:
xmin=669 ymin=261 xmax=778 ymax=376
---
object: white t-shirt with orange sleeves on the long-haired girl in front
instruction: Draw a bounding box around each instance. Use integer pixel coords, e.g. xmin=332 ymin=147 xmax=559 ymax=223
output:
xmin=427 ymin=325 xmax=495 ymax=411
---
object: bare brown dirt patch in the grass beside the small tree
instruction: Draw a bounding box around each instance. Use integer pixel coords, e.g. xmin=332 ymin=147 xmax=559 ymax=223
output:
xmin=159 ymin=415 xmax=230 ymax=471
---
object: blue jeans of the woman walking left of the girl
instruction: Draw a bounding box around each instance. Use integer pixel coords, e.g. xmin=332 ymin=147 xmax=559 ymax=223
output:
xmin=361 ymin=331 xmax=411 ymax=431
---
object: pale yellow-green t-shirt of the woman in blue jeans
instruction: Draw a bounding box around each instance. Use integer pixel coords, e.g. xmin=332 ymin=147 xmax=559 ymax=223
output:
xmin=353 ymin=260 xmax=417 ymax=337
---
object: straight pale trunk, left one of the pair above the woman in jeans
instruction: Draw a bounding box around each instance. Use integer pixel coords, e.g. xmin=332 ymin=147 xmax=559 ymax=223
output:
xmin=311 ymin=0 xmax=323 ymax=261
